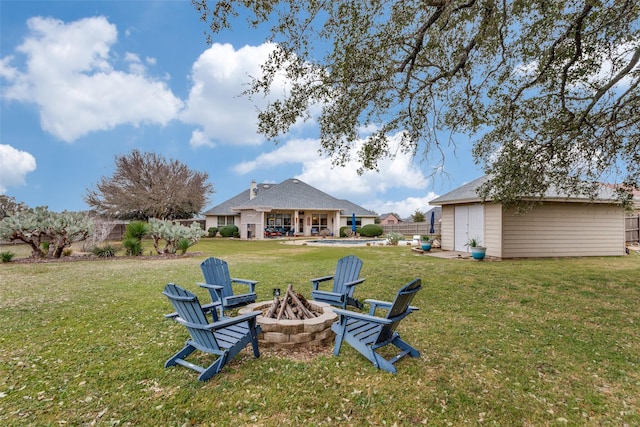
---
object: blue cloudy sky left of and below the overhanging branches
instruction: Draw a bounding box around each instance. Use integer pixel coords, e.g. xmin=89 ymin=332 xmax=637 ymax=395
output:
xmin=0 ymin=0 xmax=482 ymax=218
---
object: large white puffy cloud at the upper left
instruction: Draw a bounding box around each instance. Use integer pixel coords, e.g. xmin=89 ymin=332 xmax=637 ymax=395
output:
xmin=2 ymin=17 xmax=182 ymax=142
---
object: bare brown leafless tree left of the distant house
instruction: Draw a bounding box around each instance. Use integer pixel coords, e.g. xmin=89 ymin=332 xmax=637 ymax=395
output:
xmin=84 ymin=150 xmax=213 ymax=220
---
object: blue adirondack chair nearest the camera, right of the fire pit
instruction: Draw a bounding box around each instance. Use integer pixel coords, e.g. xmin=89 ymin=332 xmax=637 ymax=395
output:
xmin=331 ymin=279 xmax=422 ymax=374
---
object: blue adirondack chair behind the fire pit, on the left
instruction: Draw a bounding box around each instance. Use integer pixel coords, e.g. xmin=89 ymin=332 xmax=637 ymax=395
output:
xmin=198 ymin=257 xmax=258 ymax=317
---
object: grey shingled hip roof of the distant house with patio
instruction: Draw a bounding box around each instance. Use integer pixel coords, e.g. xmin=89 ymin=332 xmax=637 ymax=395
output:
xmin=205 ymin=178 xmax=377 ymax=217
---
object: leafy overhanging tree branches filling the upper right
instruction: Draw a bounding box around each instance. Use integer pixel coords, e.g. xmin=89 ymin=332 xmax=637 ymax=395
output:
xmin=192 ymin=0 xmax=640 ymax=204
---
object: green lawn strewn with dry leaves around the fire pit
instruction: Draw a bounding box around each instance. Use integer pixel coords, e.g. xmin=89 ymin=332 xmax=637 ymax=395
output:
xmin=0 ymin=239 xmax=640 ymax=426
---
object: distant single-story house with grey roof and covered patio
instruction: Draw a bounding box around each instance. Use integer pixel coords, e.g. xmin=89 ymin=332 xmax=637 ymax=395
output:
xmin=204 ymin=178 xmax=378 ymax=239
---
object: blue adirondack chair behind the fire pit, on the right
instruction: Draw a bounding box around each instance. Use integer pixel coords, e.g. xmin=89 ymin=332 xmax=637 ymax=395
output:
xmin=311 ymin=255 xmax=365 ymax=309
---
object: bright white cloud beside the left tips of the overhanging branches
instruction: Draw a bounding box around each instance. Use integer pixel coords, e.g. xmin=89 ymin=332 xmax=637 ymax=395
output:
xmin=181 ymin=43 xmax=300 ymax=145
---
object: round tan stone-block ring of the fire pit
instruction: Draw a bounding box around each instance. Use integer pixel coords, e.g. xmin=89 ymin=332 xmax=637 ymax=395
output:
xmin=238 ymin=301 xmax=338 ymax=349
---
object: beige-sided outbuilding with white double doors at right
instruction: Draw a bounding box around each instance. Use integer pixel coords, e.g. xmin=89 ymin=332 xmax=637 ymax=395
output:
xmin=429 ymin=176 xmax=625 ymax=258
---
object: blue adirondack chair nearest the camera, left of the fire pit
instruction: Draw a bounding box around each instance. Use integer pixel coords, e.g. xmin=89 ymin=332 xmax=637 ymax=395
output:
xmin=163 ymin=283 xmax=261 ymax=381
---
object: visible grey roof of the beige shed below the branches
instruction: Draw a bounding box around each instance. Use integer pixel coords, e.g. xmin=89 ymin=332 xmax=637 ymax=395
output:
xmin=429 ymin=175 xmax=618 ymax=205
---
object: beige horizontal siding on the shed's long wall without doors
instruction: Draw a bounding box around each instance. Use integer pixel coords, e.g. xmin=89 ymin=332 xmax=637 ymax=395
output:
xmin=502 ymin=203 xmax=624 ymax=258
